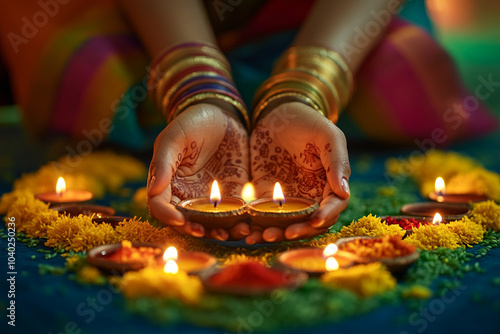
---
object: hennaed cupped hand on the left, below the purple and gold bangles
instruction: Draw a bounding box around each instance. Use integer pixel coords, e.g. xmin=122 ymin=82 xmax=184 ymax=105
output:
xmin=147 ymin=103 xmax=250 ymax=240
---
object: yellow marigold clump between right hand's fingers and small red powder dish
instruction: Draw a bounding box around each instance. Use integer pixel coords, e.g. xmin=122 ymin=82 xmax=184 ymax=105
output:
xmin=336 ymin=214 xmax=405 ymax=238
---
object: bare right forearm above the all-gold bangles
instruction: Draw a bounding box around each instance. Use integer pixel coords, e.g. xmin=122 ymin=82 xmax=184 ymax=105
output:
xmin=294 ymin=0 xmax=404 ymax=72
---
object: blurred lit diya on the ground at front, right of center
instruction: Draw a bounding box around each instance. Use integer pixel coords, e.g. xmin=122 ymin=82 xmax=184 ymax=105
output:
xmin=278 ymin=244 xmax=357 ymax=276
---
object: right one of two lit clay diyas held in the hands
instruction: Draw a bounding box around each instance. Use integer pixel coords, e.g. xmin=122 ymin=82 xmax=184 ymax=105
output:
xmin=247 ymin=182 xmax=319 ymax=227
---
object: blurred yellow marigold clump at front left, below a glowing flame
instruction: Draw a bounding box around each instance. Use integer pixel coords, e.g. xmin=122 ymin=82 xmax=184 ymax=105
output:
xmin=120 ymin=267 xmax=203 ymax=304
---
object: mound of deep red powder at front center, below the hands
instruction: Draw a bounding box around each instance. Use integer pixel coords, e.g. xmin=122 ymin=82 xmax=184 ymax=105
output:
xmin=209 ymin=262 xmax=289 ymax=288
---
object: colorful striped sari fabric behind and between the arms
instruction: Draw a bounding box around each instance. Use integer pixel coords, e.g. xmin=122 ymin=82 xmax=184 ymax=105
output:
xmin=0 ymin=0 xmax=496 ymax=149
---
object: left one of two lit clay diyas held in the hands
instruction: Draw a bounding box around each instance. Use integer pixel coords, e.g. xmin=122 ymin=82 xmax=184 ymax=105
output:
xmin=177 ymin=180 xmax=245 ymax=228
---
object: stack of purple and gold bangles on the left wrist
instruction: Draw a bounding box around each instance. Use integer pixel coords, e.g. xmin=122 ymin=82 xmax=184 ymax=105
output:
xmin=148 ymin=43 xmax=250 ymax=129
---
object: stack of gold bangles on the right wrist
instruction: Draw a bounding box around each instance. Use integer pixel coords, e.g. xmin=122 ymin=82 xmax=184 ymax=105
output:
xmin=252 ymin=46 xmax=354 ymax=126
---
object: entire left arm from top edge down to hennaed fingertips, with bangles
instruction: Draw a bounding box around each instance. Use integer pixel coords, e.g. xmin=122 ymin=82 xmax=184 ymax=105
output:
xmin=122 ymin=0 xmax=250 ymax=240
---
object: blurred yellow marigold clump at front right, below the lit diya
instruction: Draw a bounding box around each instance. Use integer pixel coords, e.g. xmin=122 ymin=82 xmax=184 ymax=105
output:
xmin=321 ymin=262 xmax=396 ymax=297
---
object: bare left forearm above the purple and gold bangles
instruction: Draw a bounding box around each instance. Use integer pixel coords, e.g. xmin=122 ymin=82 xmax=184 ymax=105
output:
xmin=120 ymin=0 xmax=216 ymax=57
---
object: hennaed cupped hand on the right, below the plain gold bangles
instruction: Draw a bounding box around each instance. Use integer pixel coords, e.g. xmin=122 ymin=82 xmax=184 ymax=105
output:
xmin=246 ymin=102 xmax=351 ymax=244
